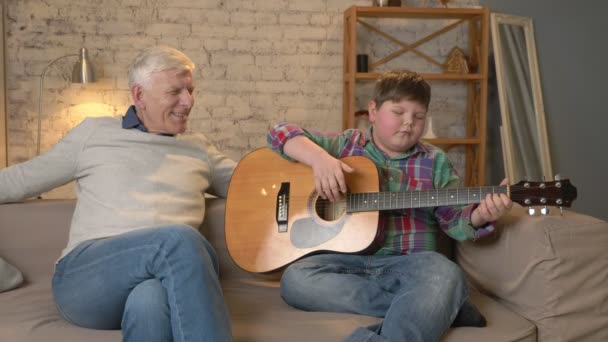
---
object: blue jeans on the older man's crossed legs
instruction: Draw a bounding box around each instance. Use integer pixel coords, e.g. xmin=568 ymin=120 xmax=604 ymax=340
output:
xmin=53 ymin=225 xmax=232 ymax=342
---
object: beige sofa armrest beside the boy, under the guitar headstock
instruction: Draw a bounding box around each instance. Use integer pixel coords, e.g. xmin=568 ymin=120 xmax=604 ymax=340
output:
xmin=456 ymin=206 xmax=608 ymax=341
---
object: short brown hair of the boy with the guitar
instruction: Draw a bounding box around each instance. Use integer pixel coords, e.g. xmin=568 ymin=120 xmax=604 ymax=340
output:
xmin=372 ymin=70 xmax=431 ymax=109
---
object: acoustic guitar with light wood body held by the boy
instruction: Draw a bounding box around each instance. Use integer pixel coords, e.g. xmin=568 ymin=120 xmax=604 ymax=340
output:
xmin=225 ymin=148 xmax=577 ymax=273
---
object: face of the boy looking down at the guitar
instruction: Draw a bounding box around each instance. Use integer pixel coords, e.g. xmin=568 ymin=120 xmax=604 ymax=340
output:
xmin=368 ymin=99 xmax=427 ymax=157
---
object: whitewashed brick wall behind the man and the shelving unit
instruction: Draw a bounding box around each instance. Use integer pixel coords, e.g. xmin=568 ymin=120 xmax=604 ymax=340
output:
xmin=6 ymin=0 xmax=478 ymax=197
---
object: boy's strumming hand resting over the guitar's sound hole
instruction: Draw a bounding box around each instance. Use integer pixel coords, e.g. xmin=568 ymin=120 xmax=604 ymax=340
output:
xmin=311 ymin=153 xmax=354 ymax=202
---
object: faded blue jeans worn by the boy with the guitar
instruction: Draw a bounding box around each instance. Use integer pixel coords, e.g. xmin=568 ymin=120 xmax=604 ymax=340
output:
xmin=281 ymin=252 xmax=468 ymax=342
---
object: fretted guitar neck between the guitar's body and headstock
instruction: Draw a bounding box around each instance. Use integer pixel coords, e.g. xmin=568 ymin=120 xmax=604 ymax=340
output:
xmin=346 ymin=185 xmax=510 ymax=212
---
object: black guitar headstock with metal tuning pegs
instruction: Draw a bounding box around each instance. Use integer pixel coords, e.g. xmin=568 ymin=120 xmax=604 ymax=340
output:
xmin=510 ymin=179 xmax=576 ymax=208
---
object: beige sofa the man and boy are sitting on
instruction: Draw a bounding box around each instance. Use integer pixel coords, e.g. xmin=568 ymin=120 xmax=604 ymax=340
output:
xmin=0 ymin=199 xmax=608 ymax=342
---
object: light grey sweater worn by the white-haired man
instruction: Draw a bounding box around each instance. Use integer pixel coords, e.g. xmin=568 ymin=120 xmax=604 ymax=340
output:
xmin=0 ymin=117 xmax=235 ymax=257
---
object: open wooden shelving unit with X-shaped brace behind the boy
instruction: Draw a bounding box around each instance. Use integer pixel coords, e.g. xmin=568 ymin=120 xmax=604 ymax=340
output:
xmin=342 ymin=6 xmax=490 ymax=186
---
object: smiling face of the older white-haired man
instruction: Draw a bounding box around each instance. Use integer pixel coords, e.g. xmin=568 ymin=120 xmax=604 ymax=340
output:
xmin=131 ymin=69 xmax=194 ymax=134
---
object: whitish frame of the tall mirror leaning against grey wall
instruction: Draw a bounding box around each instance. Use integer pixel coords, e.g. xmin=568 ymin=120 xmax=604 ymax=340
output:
xmin=490 ymin=13 xmax=553 ymax=182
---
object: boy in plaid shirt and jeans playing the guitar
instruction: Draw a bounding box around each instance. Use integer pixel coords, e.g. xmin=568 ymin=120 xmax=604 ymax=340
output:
xmin=268 ymin=71 xmax=512 ymax=342
